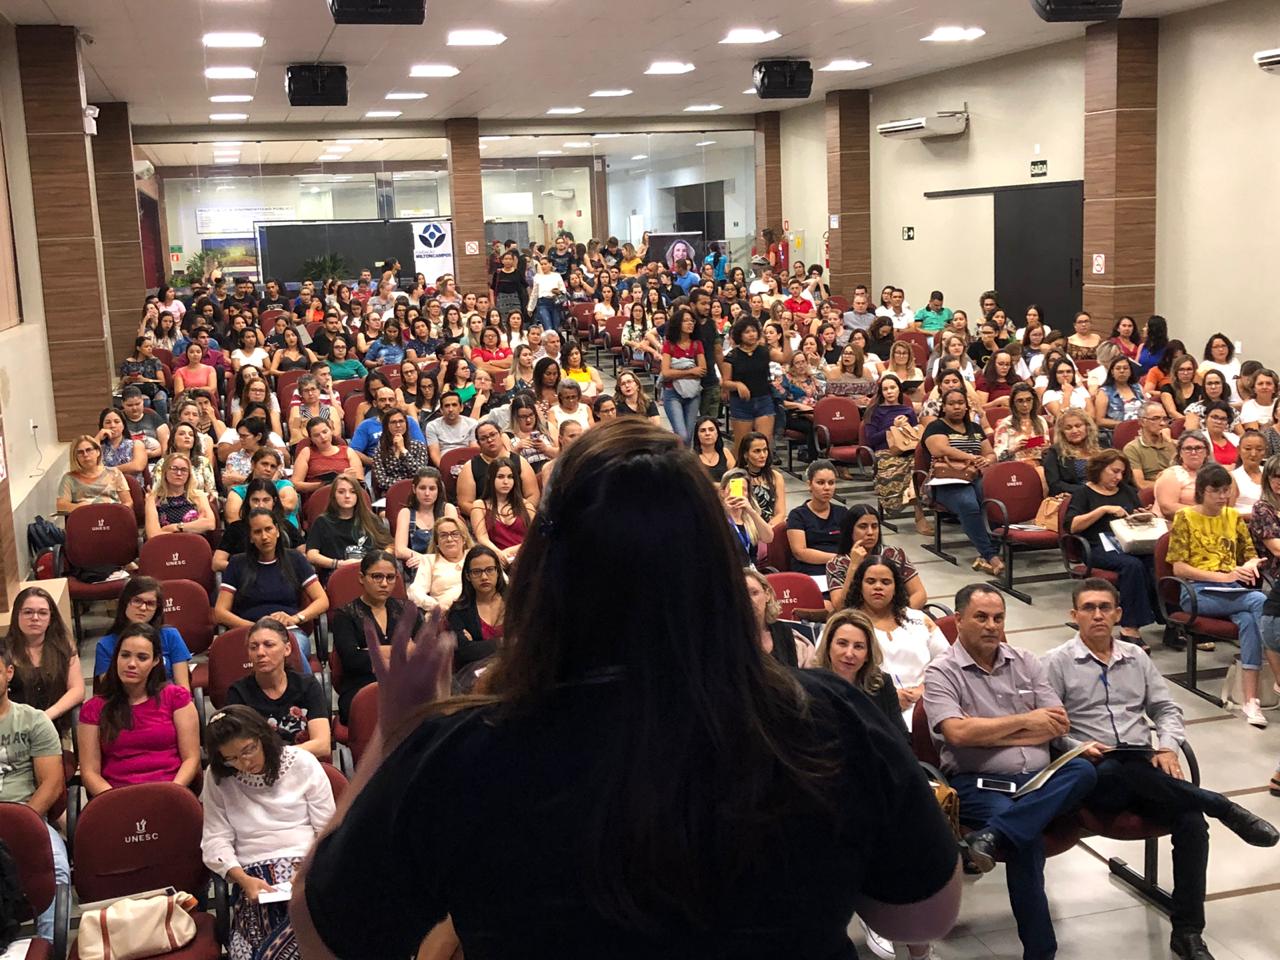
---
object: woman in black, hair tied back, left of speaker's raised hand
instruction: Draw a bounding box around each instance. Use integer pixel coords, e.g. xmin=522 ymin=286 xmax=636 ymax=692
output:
xmin=333 ymin=550 xmax=424 ymax=723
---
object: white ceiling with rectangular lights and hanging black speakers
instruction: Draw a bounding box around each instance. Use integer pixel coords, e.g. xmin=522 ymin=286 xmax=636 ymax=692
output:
xmin=0 ymin=0 xmax=1216 ymax=126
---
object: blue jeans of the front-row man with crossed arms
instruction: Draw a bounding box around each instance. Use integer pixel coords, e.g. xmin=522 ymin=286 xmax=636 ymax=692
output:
xmin=951 ymin=758 xmax=1098 ymax=960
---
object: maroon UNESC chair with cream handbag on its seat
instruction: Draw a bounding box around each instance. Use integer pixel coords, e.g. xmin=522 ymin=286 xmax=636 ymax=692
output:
xmin=72 ymin=783 xmax=229 ymax=960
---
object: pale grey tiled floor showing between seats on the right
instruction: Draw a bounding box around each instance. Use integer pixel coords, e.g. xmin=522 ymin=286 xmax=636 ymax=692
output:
xmin=787 ymin=477 xmax=1280 ymax=960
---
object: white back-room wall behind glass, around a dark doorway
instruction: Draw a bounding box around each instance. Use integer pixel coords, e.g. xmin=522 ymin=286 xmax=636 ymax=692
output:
xmin=608 ymin=147 xmax=755 ymax=242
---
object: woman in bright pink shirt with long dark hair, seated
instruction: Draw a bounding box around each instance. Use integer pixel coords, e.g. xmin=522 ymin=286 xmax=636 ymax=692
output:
xmin=76 ymin=623 xmax=200 ymax=796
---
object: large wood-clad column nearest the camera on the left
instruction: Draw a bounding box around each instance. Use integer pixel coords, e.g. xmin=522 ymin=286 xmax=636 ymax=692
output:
xmin=18 ymin=27 xmax=112 ymax=440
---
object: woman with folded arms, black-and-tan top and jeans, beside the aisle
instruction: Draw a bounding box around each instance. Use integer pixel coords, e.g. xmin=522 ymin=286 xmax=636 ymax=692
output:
xmin=923 ymin=390 xmax=1005 ymax=576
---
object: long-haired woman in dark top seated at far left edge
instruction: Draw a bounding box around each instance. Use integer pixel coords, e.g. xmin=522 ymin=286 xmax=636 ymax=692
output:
xmin=0 ymin=586 xmax=84 ymax=737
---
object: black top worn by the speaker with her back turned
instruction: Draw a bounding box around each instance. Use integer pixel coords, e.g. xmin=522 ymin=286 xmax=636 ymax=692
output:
xmin=306 ymin=671 xmax=956 ymax=960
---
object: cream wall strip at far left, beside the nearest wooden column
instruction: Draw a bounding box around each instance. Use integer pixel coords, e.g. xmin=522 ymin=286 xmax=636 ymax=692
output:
xmin=0 ymin=19 xmax=66 ymax=555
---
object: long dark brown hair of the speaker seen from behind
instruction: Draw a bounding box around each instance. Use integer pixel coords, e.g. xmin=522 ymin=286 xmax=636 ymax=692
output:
xmin=472 ymin=417 xmax=842 ymax=931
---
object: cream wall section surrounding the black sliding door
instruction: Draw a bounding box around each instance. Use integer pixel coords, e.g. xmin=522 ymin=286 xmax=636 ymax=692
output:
xmin=870 ymin=40 xmax=1084 ymax=311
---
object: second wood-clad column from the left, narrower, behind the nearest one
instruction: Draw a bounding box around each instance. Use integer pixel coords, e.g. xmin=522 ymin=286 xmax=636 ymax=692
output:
xmin=92 ymin=102 xmax=147 ymax=360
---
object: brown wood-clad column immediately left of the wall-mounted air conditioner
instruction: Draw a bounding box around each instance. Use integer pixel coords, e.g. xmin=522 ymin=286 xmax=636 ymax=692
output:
xmin=827 ymin=90 xmax=872 ymax=297
